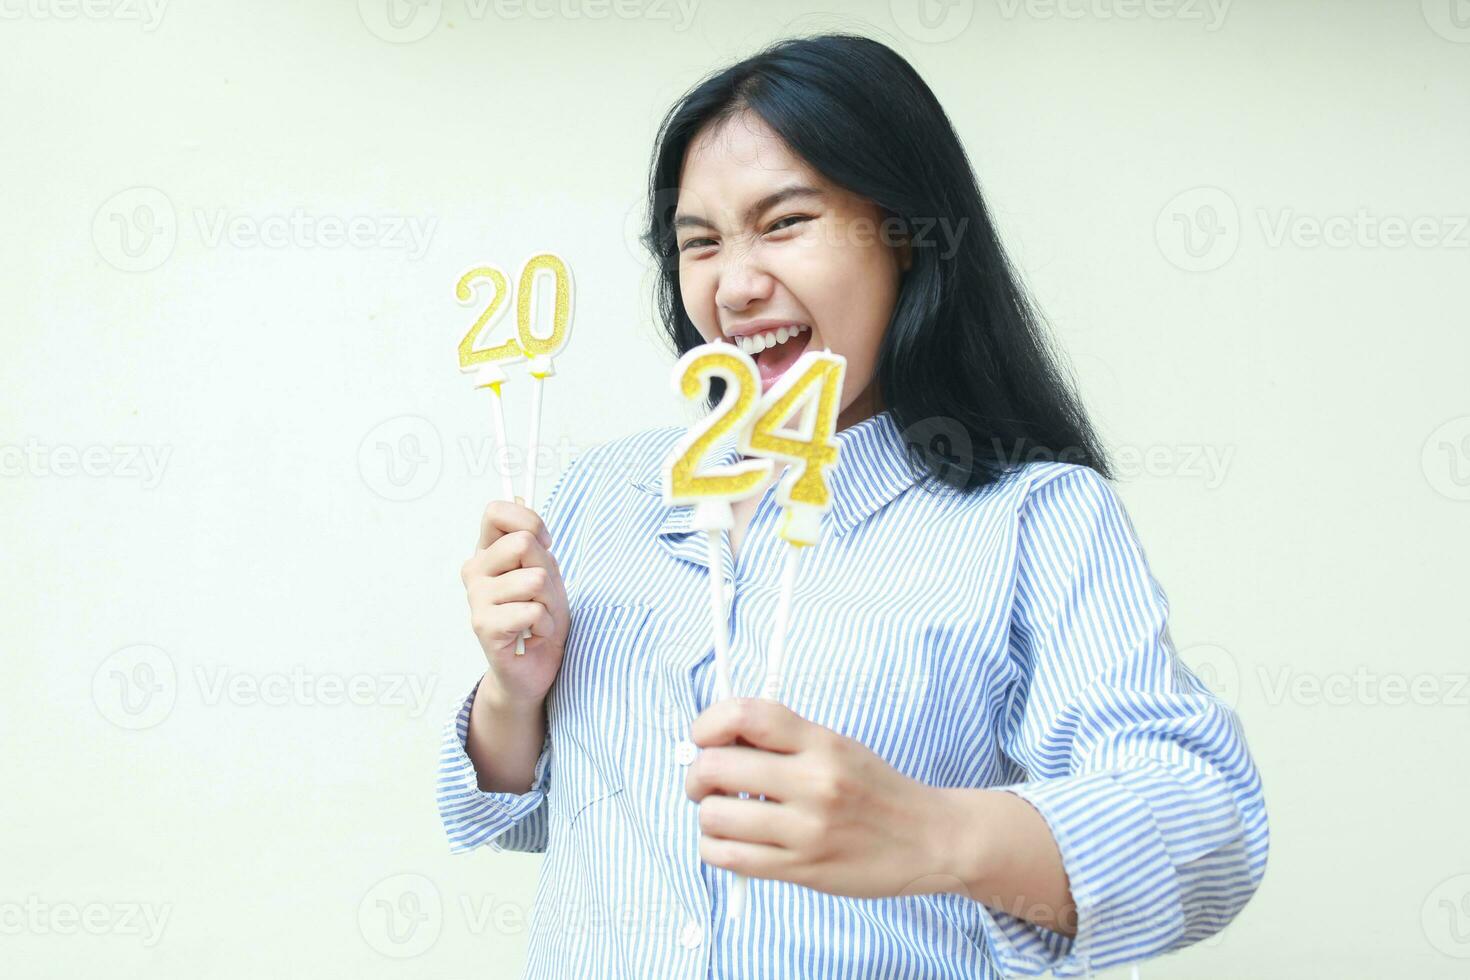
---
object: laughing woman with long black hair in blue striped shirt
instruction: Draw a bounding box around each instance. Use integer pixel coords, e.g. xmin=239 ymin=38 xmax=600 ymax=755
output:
xmin=440 ymin=35 xmax=1267 ymax=979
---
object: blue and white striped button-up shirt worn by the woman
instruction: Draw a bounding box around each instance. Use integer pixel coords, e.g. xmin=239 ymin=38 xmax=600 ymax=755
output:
xmin=438 ymin=411 xmax=1267 ymax=980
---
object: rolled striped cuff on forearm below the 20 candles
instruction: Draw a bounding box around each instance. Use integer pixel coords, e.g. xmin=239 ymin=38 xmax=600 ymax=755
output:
xmin=437 ymin=683 xmax=551 ymax=854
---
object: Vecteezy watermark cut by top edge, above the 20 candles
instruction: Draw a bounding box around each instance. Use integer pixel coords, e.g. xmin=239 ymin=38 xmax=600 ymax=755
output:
xmin=357 ymin=0 xmax=700 ymax=44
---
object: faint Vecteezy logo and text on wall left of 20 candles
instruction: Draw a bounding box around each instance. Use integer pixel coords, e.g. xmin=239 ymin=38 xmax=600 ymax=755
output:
xmin=91 ymin=185 xmax=438 ymax=272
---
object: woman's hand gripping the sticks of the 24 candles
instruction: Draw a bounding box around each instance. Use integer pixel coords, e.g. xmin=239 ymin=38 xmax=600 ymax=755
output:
xmin=685 ymin=698 xmax=947 ymax=898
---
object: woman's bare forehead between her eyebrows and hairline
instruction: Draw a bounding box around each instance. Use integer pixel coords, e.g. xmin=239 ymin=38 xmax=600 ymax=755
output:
xmin=679 ymin=110 xmax=831 ymax=212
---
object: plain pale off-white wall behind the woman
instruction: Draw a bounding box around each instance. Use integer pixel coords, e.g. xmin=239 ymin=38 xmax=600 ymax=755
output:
xmin=0 ymin=0 xmax=1470 ymax=980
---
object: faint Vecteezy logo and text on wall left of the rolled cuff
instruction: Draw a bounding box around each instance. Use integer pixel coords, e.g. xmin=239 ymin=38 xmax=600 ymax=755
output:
xmin=93 ymin=644 xmax=438 ymax=730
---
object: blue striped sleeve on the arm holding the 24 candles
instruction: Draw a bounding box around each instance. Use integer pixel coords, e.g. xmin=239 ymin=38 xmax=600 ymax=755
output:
xmin=982 ymin=466 xmax=1269 ymax=977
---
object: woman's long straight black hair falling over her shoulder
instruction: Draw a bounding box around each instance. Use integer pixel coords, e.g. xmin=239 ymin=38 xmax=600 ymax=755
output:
xmin=642 ymin=34 xmax=1110 ymax=491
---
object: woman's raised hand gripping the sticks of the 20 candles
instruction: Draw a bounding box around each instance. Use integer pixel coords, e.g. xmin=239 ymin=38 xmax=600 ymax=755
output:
xmin=460 ymin=498 xmax=572 ymax=704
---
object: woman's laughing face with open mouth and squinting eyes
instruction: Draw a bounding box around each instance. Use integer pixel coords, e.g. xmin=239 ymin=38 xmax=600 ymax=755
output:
xmin=675 ymin=112 xmax=908 ymax=429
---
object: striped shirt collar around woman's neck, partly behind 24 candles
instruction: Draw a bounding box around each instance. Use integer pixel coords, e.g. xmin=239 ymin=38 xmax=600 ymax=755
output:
xmin=634 ymin=410 xmax=920 ymax=536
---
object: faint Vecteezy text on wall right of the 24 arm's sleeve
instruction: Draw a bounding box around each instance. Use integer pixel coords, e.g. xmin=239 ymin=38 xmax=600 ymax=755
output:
xmin=1257 ymin=664 xmax=1470 ymax=708
